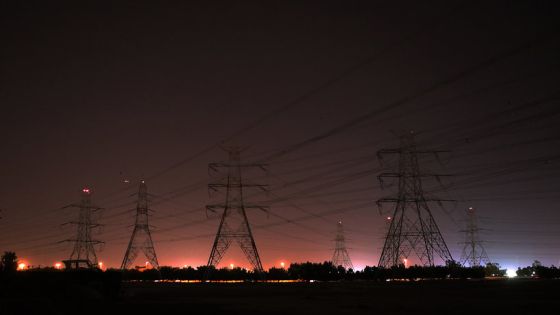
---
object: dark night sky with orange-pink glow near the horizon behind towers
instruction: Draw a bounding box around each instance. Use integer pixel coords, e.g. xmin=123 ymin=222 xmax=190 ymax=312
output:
xmin=0 ymin=1 xmax=560 ymax=269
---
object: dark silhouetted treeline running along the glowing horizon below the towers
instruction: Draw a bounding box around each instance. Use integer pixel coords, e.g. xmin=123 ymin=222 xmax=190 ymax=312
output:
xmin=6 ymin=252 xmax=560 ymax=287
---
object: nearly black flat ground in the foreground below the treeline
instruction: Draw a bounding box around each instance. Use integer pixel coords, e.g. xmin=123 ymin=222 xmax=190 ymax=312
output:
xmin=0 ymin=279 xmax=560 ymax=315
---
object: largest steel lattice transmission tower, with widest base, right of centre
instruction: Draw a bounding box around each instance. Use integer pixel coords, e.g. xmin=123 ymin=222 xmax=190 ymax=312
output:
xmin=377 ymin=132 xmax=453 ymax=267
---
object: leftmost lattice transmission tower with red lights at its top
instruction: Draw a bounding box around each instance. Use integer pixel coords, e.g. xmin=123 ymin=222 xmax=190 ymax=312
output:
xmin=64 ymin=188 xmax=103 ymax=269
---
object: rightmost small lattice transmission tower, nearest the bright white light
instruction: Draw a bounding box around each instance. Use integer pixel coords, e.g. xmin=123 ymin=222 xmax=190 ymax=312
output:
xmin=461 ymin=207 xmax=490 ymax=267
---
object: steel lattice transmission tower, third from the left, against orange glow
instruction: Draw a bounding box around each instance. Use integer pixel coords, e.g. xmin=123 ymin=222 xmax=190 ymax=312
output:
xmin=206 ymin=147 xmax=268 ymax=272
